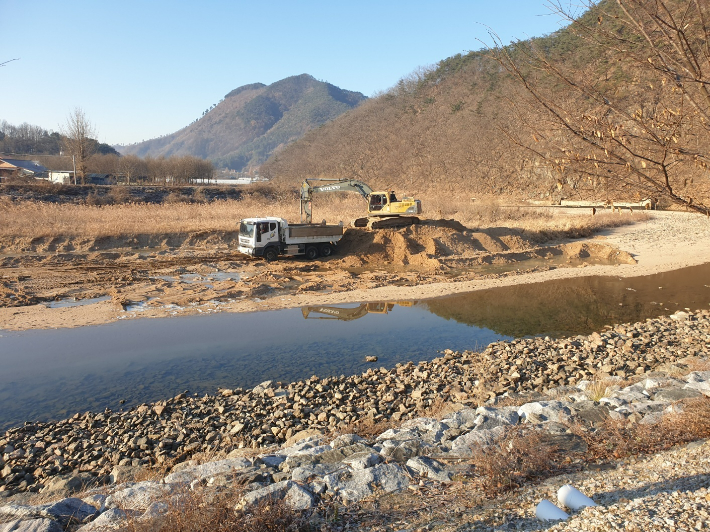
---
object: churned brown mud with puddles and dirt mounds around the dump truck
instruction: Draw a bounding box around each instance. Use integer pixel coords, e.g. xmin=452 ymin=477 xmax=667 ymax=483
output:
xmin=0 ymin=220 xmax=635 ymax=330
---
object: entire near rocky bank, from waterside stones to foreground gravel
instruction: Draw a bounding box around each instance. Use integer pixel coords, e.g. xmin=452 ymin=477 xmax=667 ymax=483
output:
xmin=0 ymin=310 xmax=710 ymax=532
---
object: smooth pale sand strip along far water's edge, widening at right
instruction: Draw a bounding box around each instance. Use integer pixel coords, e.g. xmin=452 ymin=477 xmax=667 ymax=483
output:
xmin=0 ymin=208 xmax=710 ymax=330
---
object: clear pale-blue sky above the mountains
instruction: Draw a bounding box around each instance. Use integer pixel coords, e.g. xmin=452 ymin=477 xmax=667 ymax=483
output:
xmin=0 ymin=0 xmax=560 ymax=144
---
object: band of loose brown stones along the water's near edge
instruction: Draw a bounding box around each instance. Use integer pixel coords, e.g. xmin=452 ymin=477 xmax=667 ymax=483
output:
xmin=0 ymin=310 xmax=710 ymax=495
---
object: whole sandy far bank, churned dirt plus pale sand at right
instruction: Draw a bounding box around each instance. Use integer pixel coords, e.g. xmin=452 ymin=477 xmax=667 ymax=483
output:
xmin=0 ymin=212 xmax=710 ymax=330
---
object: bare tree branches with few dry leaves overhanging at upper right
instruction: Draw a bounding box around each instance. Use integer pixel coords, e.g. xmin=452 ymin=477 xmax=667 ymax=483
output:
xmin=492 ymin=0 xmax=710 ymax=216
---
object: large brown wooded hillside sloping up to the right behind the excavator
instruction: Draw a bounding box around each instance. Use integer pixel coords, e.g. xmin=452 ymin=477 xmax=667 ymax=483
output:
xmin=261 ymin=0 xmax=710 ymax=210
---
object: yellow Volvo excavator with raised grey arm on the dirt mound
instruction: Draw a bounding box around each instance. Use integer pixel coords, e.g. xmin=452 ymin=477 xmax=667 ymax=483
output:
xmin=301 ymin=178 xmax=422 ymax=229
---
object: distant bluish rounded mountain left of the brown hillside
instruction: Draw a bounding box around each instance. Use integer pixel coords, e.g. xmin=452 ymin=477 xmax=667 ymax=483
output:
xmin=118 ymin=74 xmax=366 ymax=170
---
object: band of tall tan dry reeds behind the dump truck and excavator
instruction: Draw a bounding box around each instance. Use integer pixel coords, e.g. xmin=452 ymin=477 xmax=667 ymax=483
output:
xmin=0 ymin=186 xmax=646 ymax=240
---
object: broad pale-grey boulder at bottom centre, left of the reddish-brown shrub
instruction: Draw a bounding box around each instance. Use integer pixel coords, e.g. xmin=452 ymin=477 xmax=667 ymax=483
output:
xmin=323 ymin=464 xmax=409 ymax=504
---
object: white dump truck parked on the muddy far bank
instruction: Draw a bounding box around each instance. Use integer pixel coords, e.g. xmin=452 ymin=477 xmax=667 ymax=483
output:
xmin=238 ymin=217 xmax=343 ymax=261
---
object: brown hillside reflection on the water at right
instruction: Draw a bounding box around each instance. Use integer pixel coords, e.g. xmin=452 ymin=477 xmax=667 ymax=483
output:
xmin=423 ymin=264 xmax=710 ymax=337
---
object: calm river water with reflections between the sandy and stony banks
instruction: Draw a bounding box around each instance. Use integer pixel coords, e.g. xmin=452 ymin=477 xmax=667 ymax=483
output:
xmin=0 ymin=265 xmax=710 ymax=430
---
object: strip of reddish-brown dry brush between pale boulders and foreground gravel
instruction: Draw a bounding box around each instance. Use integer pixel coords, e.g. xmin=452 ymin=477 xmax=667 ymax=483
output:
xmin=92 ymin=398 xmax=710 ymax=532
